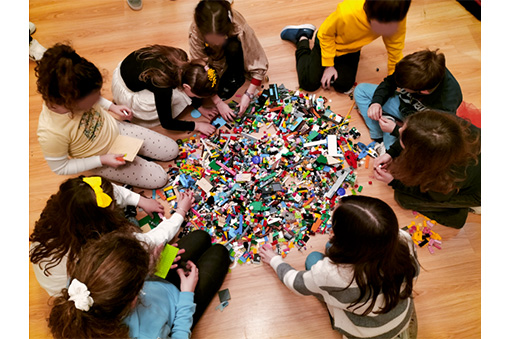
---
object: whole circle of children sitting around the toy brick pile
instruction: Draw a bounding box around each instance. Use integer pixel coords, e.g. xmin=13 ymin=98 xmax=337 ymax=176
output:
xmin=30 ymin=0 xmax=481 ymax=338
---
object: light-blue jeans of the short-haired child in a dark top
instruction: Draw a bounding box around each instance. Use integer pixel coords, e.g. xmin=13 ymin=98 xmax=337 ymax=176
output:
xmin=354 ymin=83 xmax=403 ymax=149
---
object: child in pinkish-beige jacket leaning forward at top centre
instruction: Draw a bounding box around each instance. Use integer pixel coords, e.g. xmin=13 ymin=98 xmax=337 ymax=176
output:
xmin=189 ymin=0 xmax=268 ymax=122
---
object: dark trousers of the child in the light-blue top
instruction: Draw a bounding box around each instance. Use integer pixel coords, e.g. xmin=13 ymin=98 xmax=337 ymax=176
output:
xmin=166 ymin=230 xmax=230 ymax=327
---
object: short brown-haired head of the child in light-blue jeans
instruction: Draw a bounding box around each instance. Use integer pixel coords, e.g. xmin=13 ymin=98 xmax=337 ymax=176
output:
xmin=394 ymin=49 xmax=446 ymax=91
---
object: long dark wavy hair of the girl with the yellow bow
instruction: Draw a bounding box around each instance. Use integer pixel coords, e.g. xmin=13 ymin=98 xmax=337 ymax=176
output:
xmin=29 ymin=175 xmax=139 ymax=275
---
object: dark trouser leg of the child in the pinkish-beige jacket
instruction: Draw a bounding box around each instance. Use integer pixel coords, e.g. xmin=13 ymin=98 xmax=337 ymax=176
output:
xmin=218 ymin=37 xmax=246 ymax=100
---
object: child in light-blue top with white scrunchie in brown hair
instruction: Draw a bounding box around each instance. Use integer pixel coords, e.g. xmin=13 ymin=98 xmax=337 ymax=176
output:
xmin=48 ymin=231 xmax=229 ymax=338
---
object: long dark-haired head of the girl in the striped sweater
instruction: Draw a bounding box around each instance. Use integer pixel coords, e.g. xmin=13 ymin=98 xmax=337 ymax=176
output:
xmin=327 ymin=195 xmax=416 ymax=314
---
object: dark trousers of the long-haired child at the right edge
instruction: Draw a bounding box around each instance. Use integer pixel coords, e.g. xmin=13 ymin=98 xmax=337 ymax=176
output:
xmin=394 ymin=190 xmax=481 ymax=228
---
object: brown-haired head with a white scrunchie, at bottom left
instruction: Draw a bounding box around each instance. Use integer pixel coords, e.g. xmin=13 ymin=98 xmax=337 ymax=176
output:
xmin=48 ymin=232 xmax=150 ymax=338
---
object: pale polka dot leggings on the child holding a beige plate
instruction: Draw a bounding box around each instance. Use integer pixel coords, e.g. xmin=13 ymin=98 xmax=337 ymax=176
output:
xmin=94 ymin=122 xmax=179 ymax=189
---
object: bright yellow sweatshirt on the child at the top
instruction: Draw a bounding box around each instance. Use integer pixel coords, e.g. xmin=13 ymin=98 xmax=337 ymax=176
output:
xmin=317 ymin=0 xmax=406 ymax=74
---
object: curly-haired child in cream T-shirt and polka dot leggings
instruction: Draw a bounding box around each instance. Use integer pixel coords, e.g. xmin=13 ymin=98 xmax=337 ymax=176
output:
xmin=35 ymin=44 xmax=179 ymax=189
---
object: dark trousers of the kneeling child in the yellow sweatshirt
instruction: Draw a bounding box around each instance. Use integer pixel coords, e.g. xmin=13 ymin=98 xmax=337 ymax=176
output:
xmin=296 ymin=37 xmax=361 ymax=93
